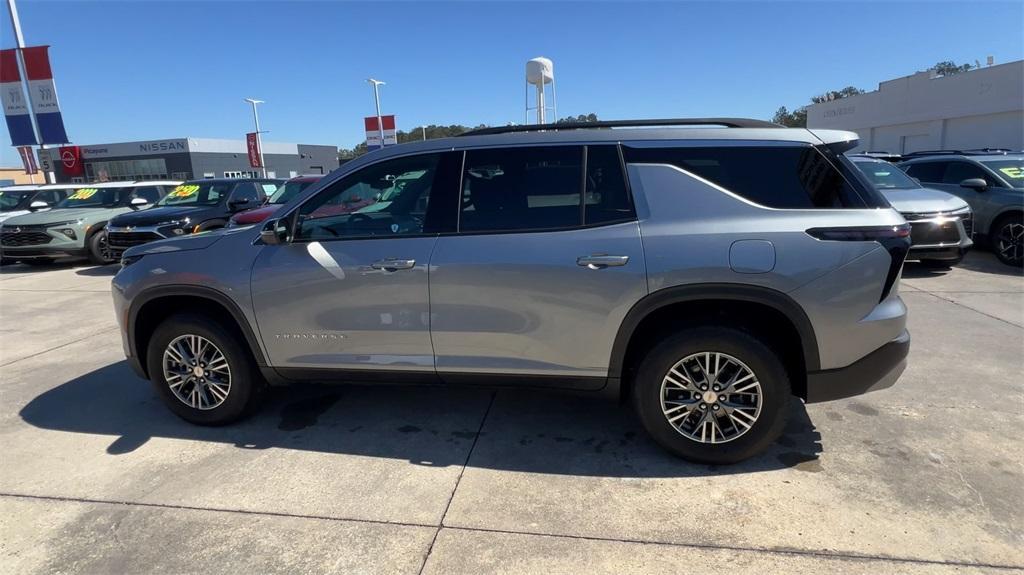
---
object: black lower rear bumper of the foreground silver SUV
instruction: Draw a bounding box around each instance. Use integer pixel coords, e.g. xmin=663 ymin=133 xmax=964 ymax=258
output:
xmin=807 ymin=329 xmax=910 ymax=403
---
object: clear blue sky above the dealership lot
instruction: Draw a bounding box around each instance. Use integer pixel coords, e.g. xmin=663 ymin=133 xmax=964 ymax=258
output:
xmin=0 ymin=0 xmax=1024 ymax=164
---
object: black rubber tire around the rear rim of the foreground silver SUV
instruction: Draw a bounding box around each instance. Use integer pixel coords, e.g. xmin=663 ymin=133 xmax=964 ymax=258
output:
xmin=633 ymin=326 xmax=792 ymax=465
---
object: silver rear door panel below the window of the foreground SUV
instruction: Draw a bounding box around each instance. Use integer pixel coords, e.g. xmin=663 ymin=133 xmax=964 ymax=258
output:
xmin=430 ymin=222 xmax=647 ymax=386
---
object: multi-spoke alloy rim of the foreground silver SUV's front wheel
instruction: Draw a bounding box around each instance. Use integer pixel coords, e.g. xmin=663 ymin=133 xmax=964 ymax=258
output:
xmin=163 ymin=334 xmax=231 ymax=411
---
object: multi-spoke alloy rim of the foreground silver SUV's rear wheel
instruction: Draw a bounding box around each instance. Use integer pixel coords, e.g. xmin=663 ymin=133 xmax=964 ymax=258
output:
xmin=660 ymin=351 xmax=763 ymax=444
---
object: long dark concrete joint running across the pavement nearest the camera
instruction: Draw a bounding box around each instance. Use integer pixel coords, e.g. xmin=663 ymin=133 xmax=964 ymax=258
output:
xmin=0 ymin=487 xmax=1024 ymax=572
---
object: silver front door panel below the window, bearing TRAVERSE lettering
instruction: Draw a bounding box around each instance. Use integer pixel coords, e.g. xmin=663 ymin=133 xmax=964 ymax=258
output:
xmin=252 ymin=236 xmax=436 ymax=372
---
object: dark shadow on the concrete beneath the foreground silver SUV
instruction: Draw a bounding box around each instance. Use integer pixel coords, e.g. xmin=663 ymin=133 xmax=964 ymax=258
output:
xmin=19 ymin=361 xmax=821 ymax=478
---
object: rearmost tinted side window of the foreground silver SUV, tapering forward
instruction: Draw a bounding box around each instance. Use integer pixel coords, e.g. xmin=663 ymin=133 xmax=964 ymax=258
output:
xmin=624 ymin=146 xmax=874 ymax=209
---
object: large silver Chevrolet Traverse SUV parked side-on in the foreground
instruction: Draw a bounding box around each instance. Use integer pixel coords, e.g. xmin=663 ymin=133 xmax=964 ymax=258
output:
xmin=113 ymin=119 xmax=909 ymax=463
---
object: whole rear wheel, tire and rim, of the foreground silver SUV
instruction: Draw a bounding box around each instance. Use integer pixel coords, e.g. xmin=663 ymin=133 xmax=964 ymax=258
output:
xmin=633 ymin=326 xmax=792 ymax=463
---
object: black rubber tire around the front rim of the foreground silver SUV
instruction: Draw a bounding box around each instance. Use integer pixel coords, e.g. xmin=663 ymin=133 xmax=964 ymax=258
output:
xmin=145 ymin=314 xmax=265 ymax=426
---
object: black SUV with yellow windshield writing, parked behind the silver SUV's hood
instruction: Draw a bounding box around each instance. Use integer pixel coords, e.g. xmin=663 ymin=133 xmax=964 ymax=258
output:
xmin=106 ymin=179 xmax=284 ymax=258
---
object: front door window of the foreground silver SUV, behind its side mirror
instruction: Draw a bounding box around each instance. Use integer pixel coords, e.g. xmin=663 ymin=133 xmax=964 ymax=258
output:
xmin=295 ymin=153 xmax=440 ymax=240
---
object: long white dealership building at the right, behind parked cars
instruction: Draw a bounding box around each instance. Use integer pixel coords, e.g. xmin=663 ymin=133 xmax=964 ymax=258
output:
xmin=807 ymin=60 xmax=1024 ymax=153
